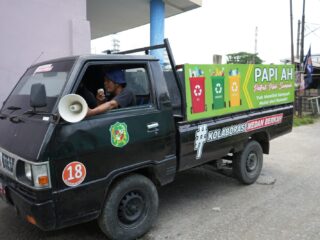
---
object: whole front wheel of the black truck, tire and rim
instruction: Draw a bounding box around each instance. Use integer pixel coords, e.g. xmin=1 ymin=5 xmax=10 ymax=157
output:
xmin=98 ymin=175 xmax=159 ymax=239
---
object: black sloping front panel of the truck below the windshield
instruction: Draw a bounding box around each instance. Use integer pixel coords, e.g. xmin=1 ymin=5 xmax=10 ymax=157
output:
xmin=0 ymin=118 xmax=50 ymax=161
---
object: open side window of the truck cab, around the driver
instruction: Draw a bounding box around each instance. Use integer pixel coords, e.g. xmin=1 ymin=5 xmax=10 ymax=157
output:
xmin=76 ymin=63 xmax=151 ymax=108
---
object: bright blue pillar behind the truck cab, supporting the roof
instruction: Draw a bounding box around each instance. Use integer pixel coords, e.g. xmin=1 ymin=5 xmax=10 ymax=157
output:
xmin=150 ymin=0 xmax=165 ymax=64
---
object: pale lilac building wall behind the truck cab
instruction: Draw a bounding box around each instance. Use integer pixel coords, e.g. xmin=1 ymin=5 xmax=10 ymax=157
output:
xmin=0 ymin=0 xmax=90 ymax=104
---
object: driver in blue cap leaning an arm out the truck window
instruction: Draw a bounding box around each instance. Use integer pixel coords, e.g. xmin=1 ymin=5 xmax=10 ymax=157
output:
xmin=87 ymin=70 xmax=136 ymax=116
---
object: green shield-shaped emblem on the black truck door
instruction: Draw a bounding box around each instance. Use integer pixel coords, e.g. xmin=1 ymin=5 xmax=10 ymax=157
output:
xmin=109 ymin=122 xmax=129 ymax=147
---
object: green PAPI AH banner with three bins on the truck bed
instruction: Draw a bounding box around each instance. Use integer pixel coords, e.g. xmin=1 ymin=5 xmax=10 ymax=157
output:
xmin=184 ymin=64 xmax=295 ymax=120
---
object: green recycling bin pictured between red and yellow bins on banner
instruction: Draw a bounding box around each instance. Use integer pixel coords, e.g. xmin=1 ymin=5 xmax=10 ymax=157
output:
xmin=211 ymin=76 xmax=226 ymax=109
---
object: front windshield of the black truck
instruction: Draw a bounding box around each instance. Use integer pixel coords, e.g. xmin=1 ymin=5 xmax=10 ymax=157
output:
xmin=2 ymin=60 xmax=74 ymax=113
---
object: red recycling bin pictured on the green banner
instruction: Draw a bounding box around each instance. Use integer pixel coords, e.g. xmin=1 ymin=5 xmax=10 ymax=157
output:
xmin=189 ymin=77 xmax=206 ymax=113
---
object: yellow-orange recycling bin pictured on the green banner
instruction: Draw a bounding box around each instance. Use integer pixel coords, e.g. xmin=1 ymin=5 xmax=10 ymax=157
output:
xmin=229 ymin=69 xmax=241 ymax=107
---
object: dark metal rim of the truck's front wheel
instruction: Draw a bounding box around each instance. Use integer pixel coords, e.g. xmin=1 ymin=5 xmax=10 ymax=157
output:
xmin=118 ymin=191 xmax=146 ymax=225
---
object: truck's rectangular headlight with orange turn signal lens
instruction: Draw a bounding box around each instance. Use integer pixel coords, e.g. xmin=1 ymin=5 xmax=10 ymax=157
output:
xmin=17 ymin=160 xmax=50 ymax=188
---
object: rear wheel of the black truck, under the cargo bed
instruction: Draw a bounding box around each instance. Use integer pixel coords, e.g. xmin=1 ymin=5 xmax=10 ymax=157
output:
xmin=232 ymin=141 xmax=263 ymax=185
